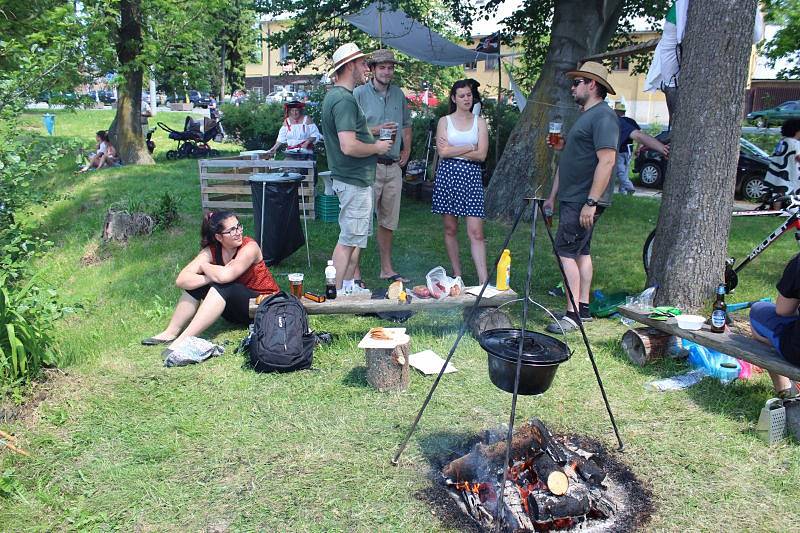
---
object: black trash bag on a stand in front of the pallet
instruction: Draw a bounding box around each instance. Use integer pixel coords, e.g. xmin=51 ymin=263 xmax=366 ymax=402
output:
xmin=249 ymin=172 xmax=306 ymax=266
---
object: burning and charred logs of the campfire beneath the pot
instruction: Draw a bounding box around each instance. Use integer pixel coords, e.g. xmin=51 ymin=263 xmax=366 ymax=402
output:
xmin=442 ymin=418 xmax=626 ymax=532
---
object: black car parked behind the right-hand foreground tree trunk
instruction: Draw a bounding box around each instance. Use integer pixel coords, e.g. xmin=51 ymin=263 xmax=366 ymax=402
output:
xmin=633 ymin=131 xmax=769 ymax=201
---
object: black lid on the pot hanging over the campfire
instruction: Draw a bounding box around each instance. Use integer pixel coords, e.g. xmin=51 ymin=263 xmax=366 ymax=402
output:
xmin=478 ymin=328 xmax=570 ymax=365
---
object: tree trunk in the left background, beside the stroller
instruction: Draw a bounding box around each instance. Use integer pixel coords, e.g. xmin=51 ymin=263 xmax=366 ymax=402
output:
xmin=109 ymin=0 xmax=155 ymax=165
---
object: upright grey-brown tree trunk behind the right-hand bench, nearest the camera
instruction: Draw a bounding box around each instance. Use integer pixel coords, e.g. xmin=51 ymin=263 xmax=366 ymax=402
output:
xmin=649 ymin=0 xmax=756 ymax=310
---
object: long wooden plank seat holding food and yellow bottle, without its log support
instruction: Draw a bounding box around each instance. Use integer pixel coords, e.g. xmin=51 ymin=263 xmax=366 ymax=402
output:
xmin=250 ymin=290 xmax=519 ymax=318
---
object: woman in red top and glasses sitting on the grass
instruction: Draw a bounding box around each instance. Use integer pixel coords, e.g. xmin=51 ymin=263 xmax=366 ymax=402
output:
xmin=142 ymin=211 xmax=280 ymax=349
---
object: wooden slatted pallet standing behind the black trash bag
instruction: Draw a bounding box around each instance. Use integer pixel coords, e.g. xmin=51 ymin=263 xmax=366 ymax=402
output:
xmin=198 ymin=156 xmax=316 ymax=220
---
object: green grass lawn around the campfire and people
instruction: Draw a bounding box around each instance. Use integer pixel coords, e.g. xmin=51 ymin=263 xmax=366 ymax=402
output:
xmin=0 ymin=111 xmax=800 ymax=531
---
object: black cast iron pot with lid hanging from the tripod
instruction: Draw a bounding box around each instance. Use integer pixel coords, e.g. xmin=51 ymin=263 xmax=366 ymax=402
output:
xmin=478 ymin=328 xmax=570 ymax=396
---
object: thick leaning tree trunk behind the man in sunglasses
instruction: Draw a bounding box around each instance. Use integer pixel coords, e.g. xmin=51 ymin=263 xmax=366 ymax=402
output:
xmin=486 ymin=0 xmax=624 ymax=218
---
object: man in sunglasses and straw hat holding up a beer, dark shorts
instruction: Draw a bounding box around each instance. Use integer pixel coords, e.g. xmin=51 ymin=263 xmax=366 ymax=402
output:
xmin=544 ymin=61 xmax=619 ymax=333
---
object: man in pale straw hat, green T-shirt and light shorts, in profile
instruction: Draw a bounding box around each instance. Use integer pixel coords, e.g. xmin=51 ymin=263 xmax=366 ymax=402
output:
xmin=322 ymin=43 xmax=393 ymax=294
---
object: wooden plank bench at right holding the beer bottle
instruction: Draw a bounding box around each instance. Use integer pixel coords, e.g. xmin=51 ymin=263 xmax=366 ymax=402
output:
xmin=618 ymin=305 xmax=800 ymax=381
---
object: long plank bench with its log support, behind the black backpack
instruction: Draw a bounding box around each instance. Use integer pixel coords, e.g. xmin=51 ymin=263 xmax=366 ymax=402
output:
xmin=250 ymin=289 xmax=519 ymax=336
